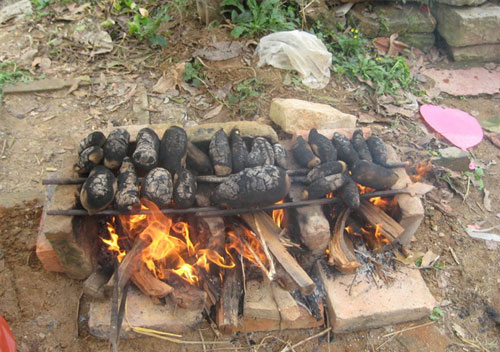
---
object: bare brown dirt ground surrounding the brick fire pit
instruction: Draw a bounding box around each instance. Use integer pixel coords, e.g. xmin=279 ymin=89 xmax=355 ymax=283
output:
xmin=0 ymin=2 xmax=500 ymax=352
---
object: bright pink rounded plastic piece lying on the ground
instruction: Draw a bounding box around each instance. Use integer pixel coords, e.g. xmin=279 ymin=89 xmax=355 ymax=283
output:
xmin=420 ymin=104 xmax=483 ymax=150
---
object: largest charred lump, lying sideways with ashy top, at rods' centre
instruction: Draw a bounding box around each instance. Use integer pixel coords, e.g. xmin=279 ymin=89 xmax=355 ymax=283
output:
xmin=211 ymin=165 xmax=290 ymax=208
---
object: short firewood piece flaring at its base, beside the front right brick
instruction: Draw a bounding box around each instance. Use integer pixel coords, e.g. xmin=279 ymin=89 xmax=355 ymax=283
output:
xmin=328 ymin=208 xmax=361 ymax=274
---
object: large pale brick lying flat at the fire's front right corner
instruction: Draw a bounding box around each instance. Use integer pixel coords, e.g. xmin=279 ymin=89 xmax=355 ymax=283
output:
xmin=316 ymin=262 xmax=436 ymax=333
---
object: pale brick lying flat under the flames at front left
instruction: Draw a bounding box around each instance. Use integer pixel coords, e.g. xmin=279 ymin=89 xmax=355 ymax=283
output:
xmin=89 ymin=287 xmax=202 ymax=339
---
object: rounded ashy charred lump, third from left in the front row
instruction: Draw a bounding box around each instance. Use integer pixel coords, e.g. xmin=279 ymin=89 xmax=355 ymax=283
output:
xmin=141 ymin=167 xmax=173 ymax=208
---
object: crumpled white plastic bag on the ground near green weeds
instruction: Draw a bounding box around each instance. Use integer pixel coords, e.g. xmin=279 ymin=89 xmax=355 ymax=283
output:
xmin=255 ymin=30 xmax=332 ymax=89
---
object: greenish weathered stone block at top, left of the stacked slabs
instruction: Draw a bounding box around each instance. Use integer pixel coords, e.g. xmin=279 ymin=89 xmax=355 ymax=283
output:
xmin=349 ymin=3 xmax=436 ymax=38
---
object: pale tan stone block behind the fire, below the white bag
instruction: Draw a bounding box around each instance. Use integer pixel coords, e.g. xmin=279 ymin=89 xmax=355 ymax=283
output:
xmin=269 ymin=98 xmax=356 ymax=134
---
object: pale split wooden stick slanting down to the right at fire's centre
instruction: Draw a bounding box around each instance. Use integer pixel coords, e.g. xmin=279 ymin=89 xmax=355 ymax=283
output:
xmin=242 ymin=211 xmax=315 ymax=295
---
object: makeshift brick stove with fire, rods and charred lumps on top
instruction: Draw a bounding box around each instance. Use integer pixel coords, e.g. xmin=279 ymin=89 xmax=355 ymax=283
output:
xmin=37 ymin=122 xmax=435 ymax=338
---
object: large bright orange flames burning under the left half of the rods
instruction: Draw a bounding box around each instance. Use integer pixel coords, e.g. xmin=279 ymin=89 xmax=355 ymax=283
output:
xmin=102 ymin=199 xmax=268 ymax=286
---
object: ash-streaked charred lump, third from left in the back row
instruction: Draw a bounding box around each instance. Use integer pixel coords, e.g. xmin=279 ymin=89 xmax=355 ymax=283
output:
xmin=132 ymin=127 xmax=160 ymax=171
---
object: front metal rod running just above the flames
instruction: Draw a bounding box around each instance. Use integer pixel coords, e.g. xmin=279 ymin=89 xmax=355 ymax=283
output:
xmin=47 ymin=188 xmax=409 ymax=217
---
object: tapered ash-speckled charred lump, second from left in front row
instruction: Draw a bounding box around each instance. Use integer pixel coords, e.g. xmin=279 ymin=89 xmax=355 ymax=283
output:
xmin=115 ymin=156 xmax=141 ymax=211
